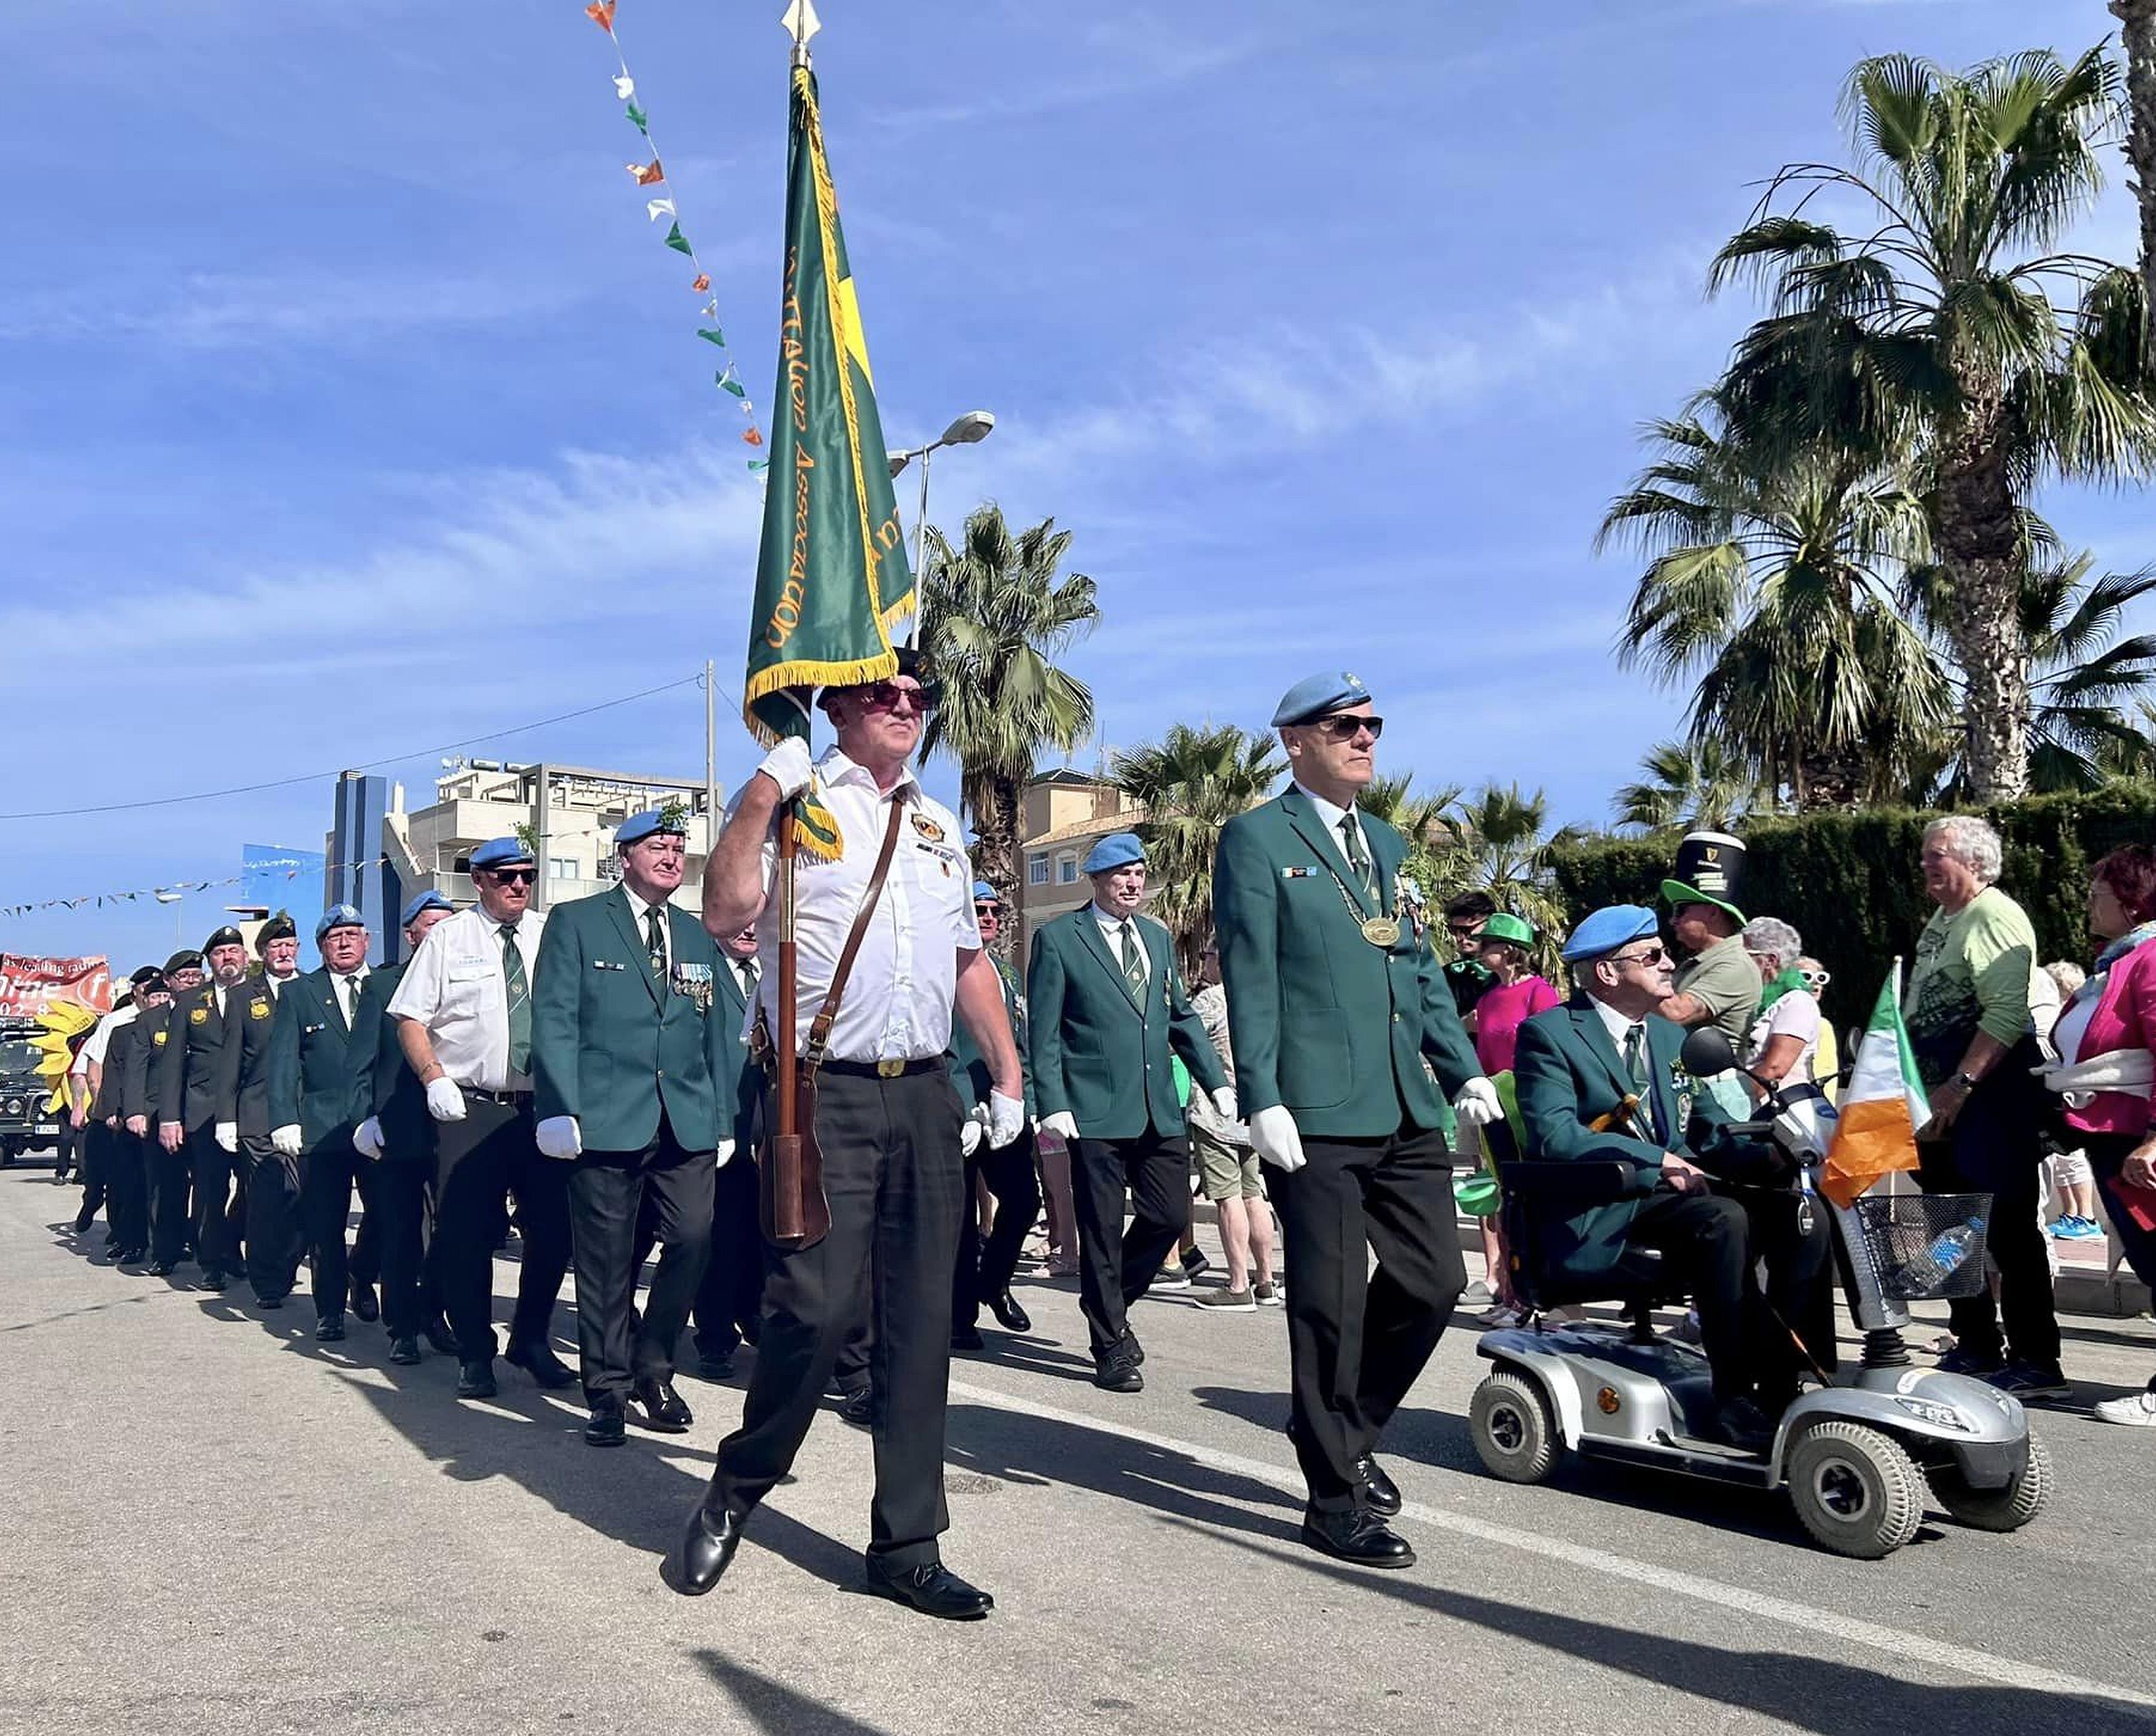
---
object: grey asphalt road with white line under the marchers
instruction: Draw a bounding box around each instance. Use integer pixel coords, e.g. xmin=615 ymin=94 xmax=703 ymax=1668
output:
xmin=0 ymin=1169 xmax=2156 ymax=1736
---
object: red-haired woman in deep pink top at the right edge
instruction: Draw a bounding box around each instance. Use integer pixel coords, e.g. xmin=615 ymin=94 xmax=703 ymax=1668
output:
xmin=2044 ymin=843 xmax=2156 ymax=1428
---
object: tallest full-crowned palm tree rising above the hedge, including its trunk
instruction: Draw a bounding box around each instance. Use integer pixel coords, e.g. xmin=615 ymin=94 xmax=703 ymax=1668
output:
xmin=1710 ymin=47 xmax=2156 ymax=802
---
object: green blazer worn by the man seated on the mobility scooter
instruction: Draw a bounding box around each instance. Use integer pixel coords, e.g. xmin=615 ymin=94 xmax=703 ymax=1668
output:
xmin=1511 ymin=994 xmax=1729 ymax=1277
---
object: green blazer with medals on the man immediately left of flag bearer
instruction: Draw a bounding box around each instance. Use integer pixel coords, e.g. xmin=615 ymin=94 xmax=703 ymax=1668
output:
xmin=533 ymin=886 xmax=720 ymax=1152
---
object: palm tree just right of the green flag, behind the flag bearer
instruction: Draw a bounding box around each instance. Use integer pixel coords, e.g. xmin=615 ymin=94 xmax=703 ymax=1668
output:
xmin=921 ymin=502 xmax=1099 ymax=910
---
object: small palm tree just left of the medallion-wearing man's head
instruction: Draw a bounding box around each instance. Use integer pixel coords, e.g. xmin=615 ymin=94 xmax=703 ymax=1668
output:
xmin=1108 ymin=723 xmax=1285 ymax=975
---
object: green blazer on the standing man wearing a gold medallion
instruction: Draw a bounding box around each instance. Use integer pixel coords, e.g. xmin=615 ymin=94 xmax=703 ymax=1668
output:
xmin=1214 ymin=787 xmax=1481 ymax=1139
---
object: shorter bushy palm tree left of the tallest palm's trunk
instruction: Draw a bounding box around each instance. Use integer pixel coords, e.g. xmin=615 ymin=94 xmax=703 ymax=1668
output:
xmin=1595 ymin=393 xmax=1947 ymax=809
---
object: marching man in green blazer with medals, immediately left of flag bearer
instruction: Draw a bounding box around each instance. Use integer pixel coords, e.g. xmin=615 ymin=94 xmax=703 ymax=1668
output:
xmin=533 ymin=809 xmax=739 ymax=1447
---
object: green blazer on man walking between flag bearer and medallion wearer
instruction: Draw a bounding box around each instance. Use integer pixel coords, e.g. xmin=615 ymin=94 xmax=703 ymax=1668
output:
xmin=1031 ymin=904 xmax=1242 ymax=1139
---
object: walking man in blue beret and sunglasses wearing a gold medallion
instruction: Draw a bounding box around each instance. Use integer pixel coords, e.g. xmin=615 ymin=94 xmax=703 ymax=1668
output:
xmin=1216 ymin=673 xmax=1503 ymax=1568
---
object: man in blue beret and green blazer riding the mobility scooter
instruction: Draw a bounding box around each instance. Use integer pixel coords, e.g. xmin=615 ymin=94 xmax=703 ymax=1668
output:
xmin=1514 ymin=904 xmax=1826 ymax=1451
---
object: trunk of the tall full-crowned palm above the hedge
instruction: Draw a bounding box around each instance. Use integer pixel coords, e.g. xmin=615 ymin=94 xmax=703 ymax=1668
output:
xmin=1938 ymin=382 xmax=2029 ymax=802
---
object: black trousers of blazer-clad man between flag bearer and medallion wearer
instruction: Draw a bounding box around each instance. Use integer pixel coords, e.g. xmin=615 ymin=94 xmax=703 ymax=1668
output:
xmin=1071 ymin=1128 xmax=1190 ymax=1361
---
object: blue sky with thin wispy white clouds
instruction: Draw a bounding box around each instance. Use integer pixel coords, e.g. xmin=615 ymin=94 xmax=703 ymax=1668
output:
xmin=0 ymin=0 xmax=2156 ymax=966
